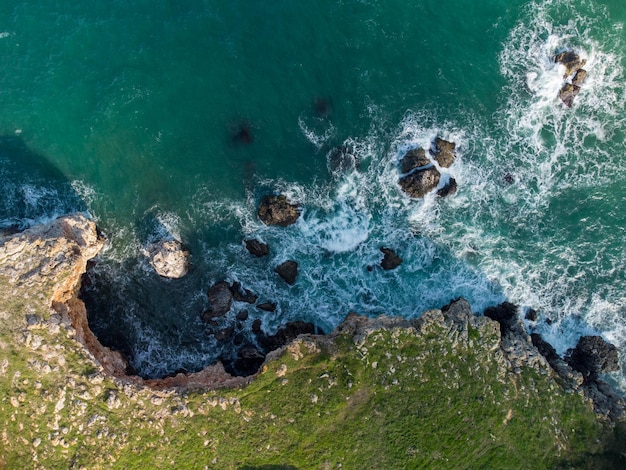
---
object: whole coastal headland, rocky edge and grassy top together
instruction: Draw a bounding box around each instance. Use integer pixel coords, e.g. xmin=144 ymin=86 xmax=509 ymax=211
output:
xmin=0 ymin=215 xmax=624 ymax=468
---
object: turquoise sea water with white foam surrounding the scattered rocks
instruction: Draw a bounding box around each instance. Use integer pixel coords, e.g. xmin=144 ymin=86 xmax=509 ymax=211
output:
xmin=0 ymin=0 xmax=626 ymax=387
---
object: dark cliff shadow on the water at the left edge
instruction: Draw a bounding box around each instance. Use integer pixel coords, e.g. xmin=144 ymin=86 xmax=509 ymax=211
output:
xmin=0 ymin=136 xmax=86 ymax=233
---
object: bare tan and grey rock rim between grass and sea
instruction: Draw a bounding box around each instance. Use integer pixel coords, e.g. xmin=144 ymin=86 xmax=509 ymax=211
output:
xmin=0 ymin=214 xmax=625 ymax=420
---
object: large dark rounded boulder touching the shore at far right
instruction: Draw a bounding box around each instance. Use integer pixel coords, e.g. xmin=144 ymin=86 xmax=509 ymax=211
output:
xmin=565 ymin=336 xmax=619 ymax=381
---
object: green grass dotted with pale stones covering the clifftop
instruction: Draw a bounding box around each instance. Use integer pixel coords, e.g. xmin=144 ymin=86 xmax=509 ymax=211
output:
xmin=0 ymin=272 xmax=626 ymax=469
